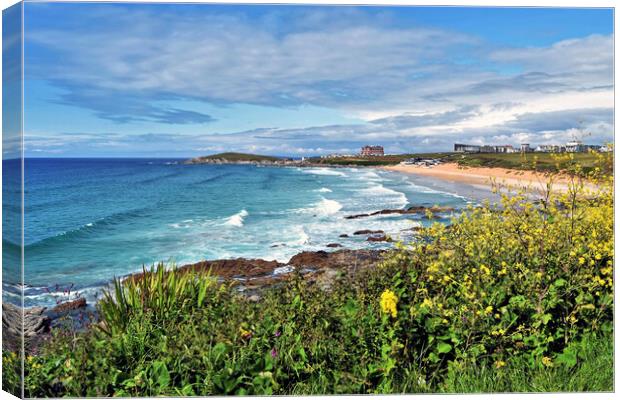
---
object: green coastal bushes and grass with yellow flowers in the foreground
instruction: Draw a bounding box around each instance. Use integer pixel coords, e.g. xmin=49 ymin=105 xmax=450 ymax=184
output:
xmin=3 ymin=154 xmax=614 ymax=397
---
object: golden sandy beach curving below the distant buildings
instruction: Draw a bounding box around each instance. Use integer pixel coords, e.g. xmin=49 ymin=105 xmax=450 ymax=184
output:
xmin=382 ymin=163 xmax=570 ymax=192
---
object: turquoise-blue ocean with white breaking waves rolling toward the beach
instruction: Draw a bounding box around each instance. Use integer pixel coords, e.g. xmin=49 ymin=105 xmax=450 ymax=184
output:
xmin=3 ymin=159 xmax=472 ymax=307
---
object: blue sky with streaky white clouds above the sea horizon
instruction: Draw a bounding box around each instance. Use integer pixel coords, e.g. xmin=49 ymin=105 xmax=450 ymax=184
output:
xmin=5 ymin=3 xmax=614 ymax=157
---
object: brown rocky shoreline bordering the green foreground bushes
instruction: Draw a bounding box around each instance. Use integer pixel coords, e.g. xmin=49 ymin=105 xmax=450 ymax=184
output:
xmin=2 ymin=248 xmax=389 ymax=354
